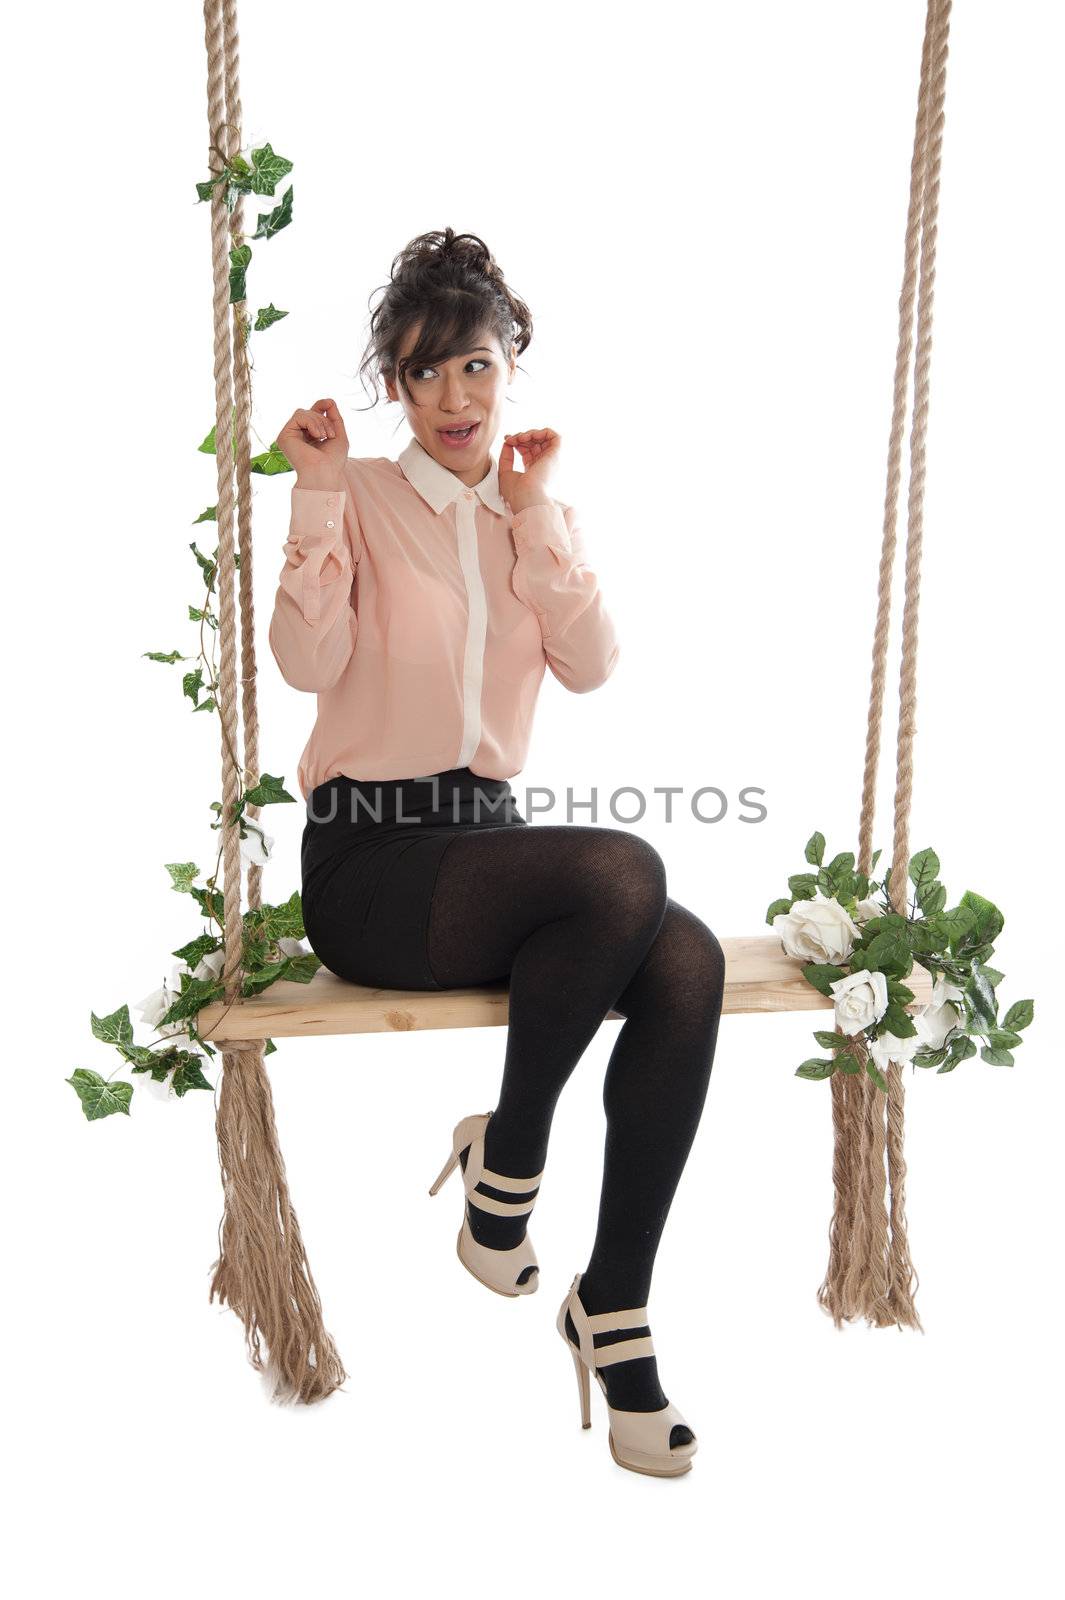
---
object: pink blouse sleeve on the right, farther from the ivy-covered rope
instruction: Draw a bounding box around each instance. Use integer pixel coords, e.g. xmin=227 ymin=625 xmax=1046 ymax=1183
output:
xmin=512 ymin=501 xmax=619 ymax=694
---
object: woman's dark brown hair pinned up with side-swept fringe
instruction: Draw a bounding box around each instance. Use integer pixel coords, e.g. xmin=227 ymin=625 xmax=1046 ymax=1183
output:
xmin=351 ymin=227 xmax=533 ymax=422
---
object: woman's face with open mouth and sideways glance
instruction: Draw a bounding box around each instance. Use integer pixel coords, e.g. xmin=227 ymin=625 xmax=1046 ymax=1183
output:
xmin=385 ymin=318 xmax=517 ymax=486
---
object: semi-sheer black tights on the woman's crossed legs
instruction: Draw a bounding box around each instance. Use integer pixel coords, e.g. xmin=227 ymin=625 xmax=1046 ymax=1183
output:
xmin=429 ymin=824 xmax=724 ymax=1410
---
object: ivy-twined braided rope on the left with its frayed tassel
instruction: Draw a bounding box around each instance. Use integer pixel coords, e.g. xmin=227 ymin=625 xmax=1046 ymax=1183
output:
xmin=203 ymin=0 xmax=345 ymax=1402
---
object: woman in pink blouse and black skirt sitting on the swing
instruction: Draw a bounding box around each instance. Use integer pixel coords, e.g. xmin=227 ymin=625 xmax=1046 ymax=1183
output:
xmin=270 ymin=229 xmax=724 ymax=1477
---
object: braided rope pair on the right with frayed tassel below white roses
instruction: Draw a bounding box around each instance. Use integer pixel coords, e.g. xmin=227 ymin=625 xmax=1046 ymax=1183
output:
xmin=817 ymin=0 xmax=950 ymax=1326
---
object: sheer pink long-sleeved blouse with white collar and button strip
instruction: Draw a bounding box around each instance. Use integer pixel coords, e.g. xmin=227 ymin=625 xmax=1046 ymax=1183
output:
xmin=269 ymin=438 xmax=619 ymax=798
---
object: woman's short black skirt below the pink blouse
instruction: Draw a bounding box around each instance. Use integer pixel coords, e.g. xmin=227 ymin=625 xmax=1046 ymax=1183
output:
xmin=301 ymin=766 xmax=529 ymax=989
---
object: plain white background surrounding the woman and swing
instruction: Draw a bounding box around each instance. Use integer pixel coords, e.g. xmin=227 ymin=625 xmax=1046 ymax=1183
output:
xmin=3 ymin=0 xmax=1065 ymax=1597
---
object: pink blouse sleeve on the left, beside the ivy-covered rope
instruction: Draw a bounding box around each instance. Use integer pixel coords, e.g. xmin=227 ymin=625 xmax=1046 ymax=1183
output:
xmin=269 ymin=486 xmax=361 ymax=693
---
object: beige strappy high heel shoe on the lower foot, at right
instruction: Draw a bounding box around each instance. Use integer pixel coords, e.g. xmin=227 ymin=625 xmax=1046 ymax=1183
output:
xmin=555 ymin=1272 xmax=699 ymax=1478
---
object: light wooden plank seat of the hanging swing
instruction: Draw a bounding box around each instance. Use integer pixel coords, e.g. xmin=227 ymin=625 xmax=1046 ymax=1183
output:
xmin=198 ymin=933 xmax=932 ymax=1045
